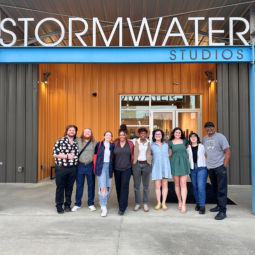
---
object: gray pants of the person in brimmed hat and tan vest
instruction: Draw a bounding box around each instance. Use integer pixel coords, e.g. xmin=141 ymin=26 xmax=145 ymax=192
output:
xmin=133 ymin=163 xmax=151 ymax=205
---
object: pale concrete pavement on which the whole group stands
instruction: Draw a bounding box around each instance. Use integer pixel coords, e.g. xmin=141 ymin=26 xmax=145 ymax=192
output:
xmin=0 ymin=179 xmax=255 ymax=255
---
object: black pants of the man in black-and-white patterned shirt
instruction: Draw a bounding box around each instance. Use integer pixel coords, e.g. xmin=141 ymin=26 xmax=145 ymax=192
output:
xmin=55 ymin=166 xmax=77 ymax=207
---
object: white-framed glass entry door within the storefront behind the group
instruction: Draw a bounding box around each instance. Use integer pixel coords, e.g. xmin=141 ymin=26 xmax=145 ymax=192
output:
xmin=150 ymin=110 xmax=176 ymax=139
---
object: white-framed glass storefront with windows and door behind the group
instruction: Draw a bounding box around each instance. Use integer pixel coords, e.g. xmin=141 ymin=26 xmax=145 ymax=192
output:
xmin=120 ymin=95 xmax=202 ymax=139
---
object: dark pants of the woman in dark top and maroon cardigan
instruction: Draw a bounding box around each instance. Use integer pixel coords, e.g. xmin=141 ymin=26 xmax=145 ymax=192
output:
xmin=114 ymin=168 xmax=132 ymax=212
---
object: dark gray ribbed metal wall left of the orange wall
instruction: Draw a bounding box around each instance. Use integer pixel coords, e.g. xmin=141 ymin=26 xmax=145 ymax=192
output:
xmin=0 ymin=64 xmax=38 ymax=183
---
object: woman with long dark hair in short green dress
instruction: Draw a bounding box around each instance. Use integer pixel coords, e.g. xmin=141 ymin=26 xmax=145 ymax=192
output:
xmin=169 ymin=127 xmax=190 ymax=213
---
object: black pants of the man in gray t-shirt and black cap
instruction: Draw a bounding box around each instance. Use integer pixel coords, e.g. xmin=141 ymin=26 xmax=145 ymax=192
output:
xmin=208 ymin=165 xmax=228 ymax=213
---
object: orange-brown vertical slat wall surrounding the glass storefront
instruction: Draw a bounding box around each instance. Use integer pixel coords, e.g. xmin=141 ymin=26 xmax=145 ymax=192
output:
xmin=38 ymin=64 xmax=217 ymax=181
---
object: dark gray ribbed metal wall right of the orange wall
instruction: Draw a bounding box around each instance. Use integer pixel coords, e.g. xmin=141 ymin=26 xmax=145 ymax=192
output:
xmin=217 ymin=63 xmax=251 ymax=185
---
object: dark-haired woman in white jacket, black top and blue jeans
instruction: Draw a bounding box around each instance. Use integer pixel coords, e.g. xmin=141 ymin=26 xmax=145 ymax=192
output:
xmin=186 ymin=133 xmax=207 ymax=214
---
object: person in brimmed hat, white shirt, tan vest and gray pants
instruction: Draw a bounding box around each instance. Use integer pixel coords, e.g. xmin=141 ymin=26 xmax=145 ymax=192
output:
xmin=132 ymin=126 xmax=151 ymax=212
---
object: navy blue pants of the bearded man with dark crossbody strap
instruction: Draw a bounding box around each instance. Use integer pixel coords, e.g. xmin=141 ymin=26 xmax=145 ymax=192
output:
xmin=75 ymin=163 xmax=95 ymax=206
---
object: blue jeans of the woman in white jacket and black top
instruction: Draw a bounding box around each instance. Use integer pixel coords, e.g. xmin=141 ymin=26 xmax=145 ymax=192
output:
xmin=190 ymin=164 xmax=207 ymax=206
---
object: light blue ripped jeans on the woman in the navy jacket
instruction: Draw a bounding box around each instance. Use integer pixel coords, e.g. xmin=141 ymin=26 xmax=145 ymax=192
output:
xmin=97 ymin=162 xmax=112 ymax=206
